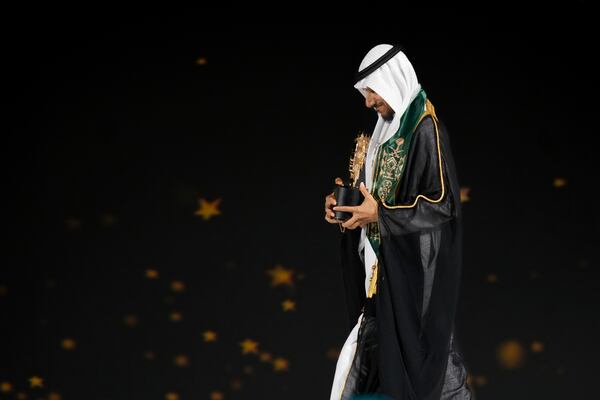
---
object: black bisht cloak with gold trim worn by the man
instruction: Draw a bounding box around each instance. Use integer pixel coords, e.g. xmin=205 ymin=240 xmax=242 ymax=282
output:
xmin=341 ymin=115 xmax=462 ymax=400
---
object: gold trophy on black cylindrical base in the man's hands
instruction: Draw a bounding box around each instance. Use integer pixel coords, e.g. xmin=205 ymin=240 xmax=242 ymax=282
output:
xmin=333 ymin=133 xmax=369 ymax=221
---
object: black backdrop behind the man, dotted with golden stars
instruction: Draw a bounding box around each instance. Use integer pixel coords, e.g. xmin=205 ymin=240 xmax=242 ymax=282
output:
xmin=0 ymin=7 xmax=600 ymax=400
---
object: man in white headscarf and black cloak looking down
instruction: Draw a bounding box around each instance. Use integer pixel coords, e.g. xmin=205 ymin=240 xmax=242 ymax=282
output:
xmin=325 ymin=45 xmax=473 ymax=400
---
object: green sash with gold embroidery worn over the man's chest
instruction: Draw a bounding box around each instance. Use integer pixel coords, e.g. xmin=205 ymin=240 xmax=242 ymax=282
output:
xmin=367 ymin=89 xmax=427 ymax=259
